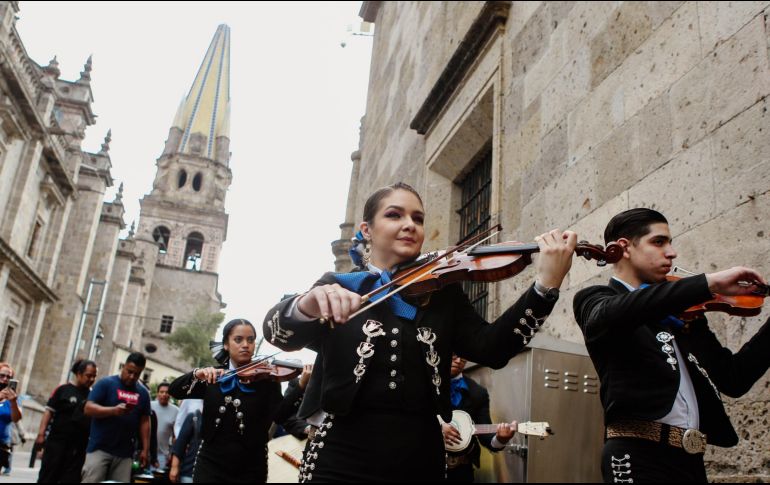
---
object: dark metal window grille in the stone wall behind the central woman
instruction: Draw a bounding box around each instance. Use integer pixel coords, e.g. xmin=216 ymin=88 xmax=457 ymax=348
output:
xmin=457 ymin=147 xmax=492 ymax=318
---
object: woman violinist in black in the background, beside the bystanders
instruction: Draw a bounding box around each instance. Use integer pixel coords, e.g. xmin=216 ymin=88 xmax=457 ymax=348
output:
xmin=169 ymin=319 xmax=295 ymax=483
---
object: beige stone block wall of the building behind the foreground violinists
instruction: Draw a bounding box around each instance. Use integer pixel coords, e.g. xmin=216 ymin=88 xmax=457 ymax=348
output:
xmin=348 ymin=2 xmax=770 ymax=479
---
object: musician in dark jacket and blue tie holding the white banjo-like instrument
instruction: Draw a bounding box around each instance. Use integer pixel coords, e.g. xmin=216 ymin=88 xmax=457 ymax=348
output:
xmin=441 ymin=355 xmax=516 ymax=483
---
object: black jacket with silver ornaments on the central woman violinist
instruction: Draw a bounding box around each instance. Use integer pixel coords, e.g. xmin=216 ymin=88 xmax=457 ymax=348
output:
xmin=263 ymin=273 xmax=555 ymax=422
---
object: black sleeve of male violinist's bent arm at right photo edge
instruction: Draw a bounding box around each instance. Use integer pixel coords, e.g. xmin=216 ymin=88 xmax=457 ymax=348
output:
xmin=687 ymin=319 xmax=770 ymax=397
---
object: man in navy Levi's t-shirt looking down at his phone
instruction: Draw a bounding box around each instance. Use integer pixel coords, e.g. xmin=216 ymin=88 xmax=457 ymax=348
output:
xmin=83 ymin=352 xmax=150 ymax=483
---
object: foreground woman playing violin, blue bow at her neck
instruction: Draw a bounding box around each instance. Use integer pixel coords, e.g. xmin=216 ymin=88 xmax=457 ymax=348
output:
xmin=264 ymin=183 xmax=576 ymax=482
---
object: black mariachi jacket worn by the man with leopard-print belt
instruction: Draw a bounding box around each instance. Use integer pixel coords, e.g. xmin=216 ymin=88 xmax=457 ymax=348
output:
xmin=574 ymin=275 xmax=770 ymax=447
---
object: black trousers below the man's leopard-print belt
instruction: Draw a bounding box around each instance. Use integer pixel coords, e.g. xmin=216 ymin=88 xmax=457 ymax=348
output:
xmin=602 ymin=438 xmax=708 ymax=483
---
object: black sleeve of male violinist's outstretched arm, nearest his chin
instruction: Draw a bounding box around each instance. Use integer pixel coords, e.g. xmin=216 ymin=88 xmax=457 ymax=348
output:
xmin=573 ymin=275 xmax=711 ymax=344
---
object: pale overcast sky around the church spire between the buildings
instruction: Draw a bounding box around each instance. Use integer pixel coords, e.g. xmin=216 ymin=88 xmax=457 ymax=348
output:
xmin=17 ymin=2 xmax=372 ymax=360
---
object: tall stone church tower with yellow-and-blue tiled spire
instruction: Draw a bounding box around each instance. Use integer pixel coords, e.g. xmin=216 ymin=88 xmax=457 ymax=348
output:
xmin=128 ymin=25 xmax=232 ymax=366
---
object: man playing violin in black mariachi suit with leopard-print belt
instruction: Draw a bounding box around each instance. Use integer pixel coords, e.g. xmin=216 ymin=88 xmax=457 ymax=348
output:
xmin=574 ymin=209 xmax=770 ymax=483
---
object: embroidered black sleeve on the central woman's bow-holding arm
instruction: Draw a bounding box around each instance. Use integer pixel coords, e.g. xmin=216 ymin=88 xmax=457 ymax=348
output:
xmin=262 ymin=273 xmax=335 ymax=351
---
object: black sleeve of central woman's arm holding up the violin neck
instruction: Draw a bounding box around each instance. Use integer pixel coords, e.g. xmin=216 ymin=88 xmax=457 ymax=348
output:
xmin=448 ymin=285 xmax=556 ymax=369
